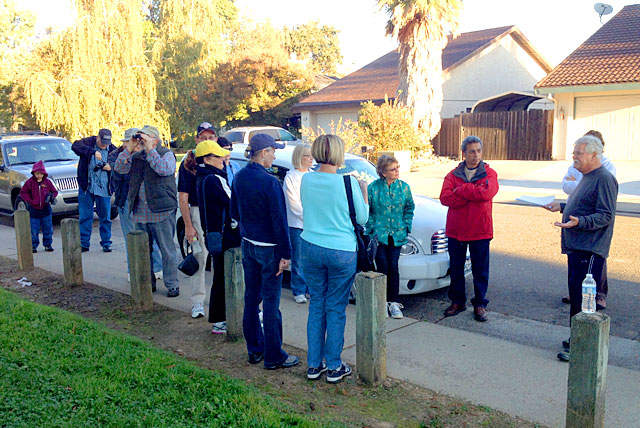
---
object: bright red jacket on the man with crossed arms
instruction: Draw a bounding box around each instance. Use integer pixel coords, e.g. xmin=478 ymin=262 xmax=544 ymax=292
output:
xmin=440 ymin=162 xmax=498 ymax=241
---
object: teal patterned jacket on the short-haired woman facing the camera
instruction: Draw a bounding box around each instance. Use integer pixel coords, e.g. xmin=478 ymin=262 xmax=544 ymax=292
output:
xmin=366 ymin=178 xmax=415 ymax=247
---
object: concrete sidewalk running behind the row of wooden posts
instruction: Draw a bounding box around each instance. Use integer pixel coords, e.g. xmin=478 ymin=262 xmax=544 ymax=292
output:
xmin=0 ymin=220 xmax=640 ymax=428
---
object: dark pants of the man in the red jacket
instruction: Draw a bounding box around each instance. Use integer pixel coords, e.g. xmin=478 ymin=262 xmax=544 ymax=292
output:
xmin=449 ymin=237 xmax=491 ymax=308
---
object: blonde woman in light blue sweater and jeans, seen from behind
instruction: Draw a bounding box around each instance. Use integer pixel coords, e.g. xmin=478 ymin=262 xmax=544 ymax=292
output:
xmin=300 ymin=135 xmax=369 ymax=383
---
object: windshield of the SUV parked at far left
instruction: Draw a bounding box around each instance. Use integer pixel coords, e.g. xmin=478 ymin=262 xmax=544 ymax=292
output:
xmin=5 ymin=139 xmax=78 ymax=165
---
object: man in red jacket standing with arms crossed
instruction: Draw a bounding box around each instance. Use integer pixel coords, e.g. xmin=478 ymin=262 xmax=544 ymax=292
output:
xmin=440 ymin=135 xmax=498 ymax=321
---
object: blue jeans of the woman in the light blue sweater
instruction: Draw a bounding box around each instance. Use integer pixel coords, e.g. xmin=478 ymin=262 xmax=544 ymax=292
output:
xmin=302 ymin=239 xmax=357 ymax=370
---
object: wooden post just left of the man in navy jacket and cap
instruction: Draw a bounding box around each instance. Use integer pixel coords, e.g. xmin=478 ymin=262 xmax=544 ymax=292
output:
xmin=224 ymin=248 xmax=244 ymax=341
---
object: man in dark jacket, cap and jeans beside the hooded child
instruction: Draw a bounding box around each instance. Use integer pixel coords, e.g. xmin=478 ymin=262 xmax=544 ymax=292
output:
xmin=71 ymin=129 xmax=116 ymax=253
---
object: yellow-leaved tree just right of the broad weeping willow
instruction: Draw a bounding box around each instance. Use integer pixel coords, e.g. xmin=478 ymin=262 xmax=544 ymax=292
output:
xmin=149 ymin=0 xmax=237 ymax=133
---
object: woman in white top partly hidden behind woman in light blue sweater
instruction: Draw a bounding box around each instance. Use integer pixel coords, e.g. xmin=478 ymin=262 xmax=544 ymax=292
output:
xmin=283 ymin=144 xmax=313 ymax=303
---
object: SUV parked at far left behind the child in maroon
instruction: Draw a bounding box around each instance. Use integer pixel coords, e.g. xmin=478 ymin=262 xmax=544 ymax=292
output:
xmin=0 ymin=134 xmax=78 ymax=216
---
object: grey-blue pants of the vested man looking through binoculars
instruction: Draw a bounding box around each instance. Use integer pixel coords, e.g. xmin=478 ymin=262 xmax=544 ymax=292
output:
xmin=135 ymin=211 xmax=179 ymax=290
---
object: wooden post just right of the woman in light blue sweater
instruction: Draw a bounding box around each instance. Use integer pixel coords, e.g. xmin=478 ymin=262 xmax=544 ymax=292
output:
xmin=356 ymin=272 xmax=387 ymax=386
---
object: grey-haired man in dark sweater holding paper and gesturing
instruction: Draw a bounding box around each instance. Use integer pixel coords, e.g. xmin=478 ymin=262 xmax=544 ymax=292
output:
xmin=544 ymin=135 xmax=618 ymax=361
